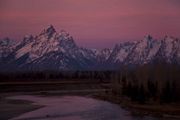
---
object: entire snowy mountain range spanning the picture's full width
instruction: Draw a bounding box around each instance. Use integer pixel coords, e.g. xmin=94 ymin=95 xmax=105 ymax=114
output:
xmin=0 ymin=25 xmax=180 ymax=71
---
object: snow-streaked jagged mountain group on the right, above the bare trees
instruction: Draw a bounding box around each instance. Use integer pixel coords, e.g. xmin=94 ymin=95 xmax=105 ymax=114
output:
xmin=109 ymin=35 xmax=180 ymax=65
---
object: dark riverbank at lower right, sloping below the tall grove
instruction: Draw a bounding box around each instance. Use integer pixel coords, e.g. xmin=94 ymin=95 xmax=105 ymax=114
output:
xmin=93 ymin=94 xmax=180 ymax=120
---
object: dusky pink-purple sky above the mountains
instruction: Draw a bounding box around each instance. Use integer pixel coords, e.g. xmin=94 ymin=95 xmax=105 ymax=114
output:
xmin=0 ymin=0 xmax=180 ymax=48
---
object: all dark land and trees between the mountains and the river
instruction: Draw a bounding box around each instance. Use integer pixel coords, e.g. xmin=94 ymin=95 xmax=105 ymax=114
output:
xmin=0 ymin=66 xmax=180 ymax=120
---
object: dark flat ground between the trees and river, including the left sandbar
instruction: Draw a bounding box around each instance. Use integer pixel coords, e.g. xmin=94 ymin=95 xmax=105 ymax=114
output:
xmin=0 ymin=79 xmax=180 ymax=120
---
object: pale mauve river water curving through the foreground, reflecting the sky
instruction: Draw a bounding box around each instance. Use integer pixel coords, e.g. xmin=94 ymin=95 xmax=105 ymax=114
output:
xmin=8 ymin=95 xmax=167 ymax=120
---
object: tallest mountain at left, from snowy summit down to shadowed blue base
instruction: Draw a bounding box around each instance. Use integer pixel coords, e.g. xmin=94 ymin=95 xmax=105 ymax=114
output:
xmin=2 ymin=26 xmax=96 ymax=70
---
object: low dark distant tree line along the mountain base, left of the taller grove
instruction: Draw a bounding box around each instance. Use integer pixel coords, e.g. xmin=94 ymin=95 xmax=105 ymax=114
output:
xmin=0 ymin=71 xmax=112 ymax=82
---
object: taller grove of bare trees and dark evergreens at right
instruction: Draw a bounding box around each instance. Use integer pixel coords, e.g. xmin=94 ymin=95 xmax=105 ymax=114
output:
xmin=112 ymin=64 xmax=180 ymax=104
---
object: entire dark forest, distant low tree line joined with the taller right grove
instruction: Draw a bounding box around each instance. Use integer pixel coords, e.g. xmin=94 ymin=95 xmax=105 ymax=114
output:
xmin=0 ymin=63 xmax=180 ymax=104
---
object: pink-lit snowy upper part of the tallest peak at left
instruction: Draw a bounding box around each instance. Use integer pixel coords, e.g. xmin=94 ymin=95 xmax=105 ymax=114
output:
xmin=16 ymin=25 xmax=77 ymax=62
